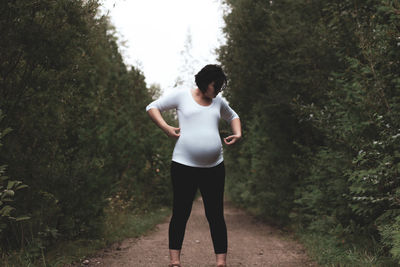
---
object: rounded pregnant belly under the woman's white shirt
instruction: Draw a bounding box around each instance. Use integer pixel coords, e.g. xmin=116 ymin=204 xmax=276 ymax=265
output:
xmin=175 ymin=133 xmax=222 ymax=165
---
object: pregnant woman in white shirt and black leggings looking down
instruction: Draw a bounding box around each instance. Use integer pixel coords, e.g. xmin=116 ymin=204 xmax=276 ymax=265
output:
xmin=146 ymin=65 xmax=242 ymax=267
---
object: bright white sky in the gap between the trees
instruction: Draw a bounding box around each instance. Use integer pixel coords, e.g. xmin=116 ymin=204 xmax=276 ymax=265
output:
xmin=101 ymin=0 xmax=225 ymax=91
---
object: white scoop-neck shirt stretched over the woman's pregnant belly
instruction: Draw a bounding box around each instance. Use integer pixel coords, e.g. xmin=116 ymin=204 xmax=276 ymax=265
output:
xmin=146 ymin=89 xmax=239 ymax=168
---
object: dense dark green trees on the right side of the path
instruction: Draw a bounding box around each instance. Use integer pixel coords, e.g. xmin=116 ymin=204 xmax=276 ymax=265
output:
xmin=219 ymin=0 xmax=400 ymax=262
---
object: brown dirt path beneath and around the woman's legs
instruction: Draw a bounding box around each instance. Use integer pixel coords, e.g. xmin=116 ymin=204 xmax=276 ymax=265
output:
xmin=82 ymin=198 xmax=318 ymax=267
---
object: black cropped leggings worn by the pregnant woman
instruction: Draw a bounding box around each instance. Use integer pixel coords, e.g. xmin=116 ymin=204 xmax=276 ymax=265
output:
xmin=169 ymin=161 xmax=228 ymax=254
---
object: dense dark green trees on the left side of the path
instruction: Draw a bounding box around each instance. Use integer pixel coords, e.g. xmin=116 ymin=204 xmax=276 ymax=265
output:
xmin=0 ymin=0 xmax=171 ymax=256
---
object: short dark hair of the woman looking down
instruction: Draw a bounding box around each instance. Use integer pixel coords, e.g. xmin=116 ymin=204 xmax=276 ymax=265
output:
xmin=194 ymin=64 xmax=226 ymax=93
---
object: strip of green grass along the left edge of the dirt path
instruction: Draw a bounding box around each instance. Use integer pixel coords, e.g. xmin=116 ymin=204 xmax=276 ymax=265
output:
xmin=0 ymin=207 xmax=171 ymax=267
